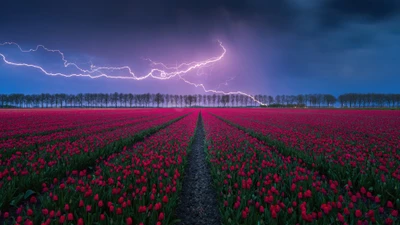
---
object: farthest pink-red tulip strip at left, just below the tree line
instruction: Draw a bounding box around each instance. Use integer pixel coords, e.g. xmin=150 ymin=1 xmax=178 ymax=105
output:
xmin=0 ymin=109 xmax=168 ymax=140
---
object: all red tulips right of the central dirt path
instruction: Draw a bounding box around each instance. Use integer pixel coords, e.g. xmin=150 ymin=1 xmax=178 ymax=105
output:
xmin=204 ymin=109 xmax=400 ymax=224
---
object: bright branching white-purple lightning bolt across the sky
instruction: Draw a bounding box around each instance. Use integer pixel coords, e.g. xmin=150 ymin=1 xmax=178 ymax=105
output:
xmin=0 ymin=41 xmax=265 ymax=105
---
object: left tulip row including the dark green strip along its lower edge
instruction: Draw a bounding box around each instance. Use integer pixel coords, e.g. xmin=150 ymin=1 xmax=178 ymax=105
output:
xmin=0 ymin=111 xmax=187 ymax=209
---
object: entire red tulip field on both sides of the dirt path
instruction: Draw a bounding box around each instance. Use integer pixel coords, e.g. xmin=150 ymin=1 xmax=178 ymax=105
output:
xmin=0 ymin=108 xmax=400 ymax=225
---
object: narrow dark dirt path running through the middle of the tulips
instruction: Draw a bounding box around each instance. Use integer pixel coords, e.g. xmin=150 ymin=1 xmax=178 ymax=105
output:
xmin=177 ymin=114 xmax=221 ymax=225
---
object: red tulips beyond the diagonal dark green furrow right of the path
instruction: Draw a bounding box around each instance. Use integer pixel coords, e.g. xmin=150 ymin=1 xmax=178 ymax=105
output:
xmin=212 ymin=110 xmax=400 ymax=207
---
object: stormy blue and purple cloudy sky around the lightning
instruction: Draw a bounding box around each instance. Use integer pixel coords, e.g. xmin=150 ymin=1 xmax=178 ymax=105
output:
xmin=0 ymin=0 xmax=400 ymax=95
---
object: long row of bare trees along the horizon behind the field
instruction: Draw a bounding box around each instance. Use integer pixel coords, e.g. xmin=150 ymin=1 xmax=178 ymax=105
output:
xmin=0 ymin=92 xmax=400 ymax=108
